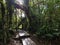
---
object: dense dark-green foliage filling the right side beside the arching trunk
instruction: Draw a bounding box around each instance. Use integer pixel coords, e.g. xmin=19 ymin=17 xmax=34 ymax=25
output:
xmin=29 ymin=0 xmax=60 ymax=38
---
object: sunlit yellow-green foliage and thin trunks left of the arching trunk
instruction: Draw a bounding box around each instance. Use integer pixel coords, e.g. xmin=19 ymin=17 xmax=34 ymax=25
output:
xmin=0 ymin=0 xmax=29 ymax=41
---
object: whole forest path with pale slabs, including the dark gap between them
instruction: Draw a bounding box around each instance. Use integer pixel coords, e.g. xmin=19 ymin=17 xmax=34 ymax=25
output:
xmin=8 ymin=31 xmax=40 ymax=45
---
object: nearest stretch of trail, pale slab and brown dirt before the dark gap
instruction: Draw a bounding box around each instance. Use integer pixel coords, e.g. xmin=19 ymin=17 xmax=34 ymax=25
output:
xmin=8 ymin=37 xmax=40 ymax=45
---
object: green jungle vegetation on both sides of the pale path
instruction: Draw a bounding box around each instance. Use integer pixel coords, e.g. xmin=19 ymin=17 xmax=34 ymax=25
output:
xmin=0 ymin=0 xmax=60 ymax=42
